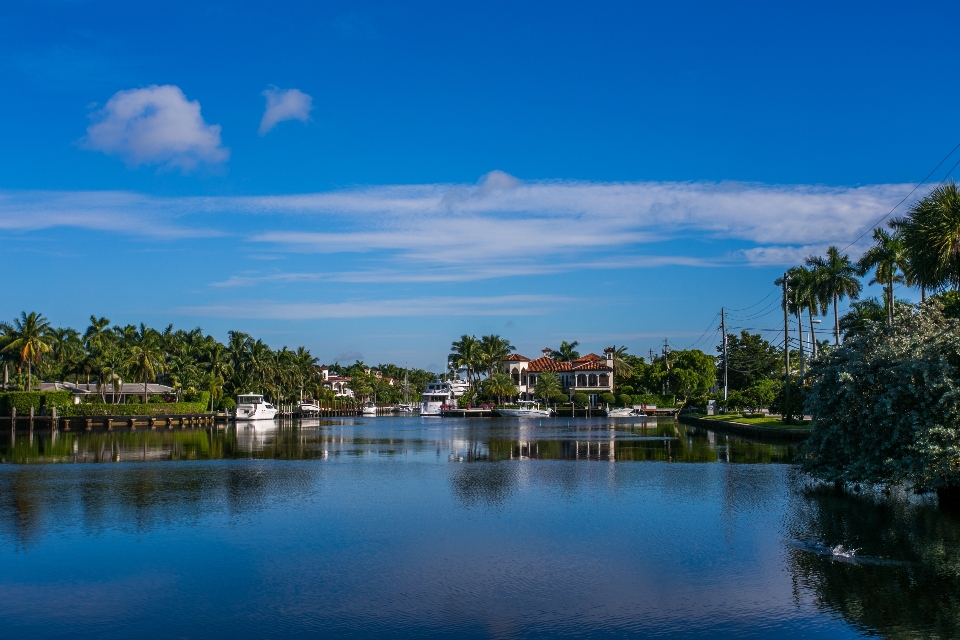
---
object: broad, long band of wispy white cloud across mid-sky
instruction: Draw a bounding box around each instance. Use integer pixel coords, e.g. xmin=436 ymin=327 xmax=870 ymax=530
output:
xmin=0 ymin=171 xmax=921 ymax=276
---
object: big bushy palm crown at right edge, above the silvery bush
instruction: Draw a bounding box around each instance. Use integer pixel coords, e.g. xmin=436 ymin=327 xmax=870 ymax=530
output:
xmin=891 ymin=181 xmax=960 ymax=289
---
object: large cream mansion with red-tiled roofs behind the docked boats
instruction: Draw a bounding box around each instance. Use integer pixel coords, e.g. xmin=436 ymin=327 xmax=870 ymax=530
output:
xmin=502 ymin=347 xmax=613 ymax=405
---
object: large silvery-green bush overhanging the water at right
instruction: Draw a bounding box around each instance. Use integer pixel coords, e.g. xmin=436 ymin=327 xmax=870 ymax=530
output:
xmin=802 ymin=300 xmax=960 ymax=491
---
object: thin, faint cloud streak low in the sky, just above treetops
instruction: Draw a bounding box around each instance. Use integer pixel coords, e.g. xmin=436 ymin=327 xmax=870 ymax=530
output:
xmin=177 ymin=295 xmax=576 ymax=320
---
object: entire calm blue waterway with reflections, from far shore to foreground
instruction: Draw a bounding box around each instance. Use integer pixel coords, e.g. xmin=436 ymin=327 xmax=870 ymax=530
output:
xmin=0 ymin=418 xmax=960 ymax=639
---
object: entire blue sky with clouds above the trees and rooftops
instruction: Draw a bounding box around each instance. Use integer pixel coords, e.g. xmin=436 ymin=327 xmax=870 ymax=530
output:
xmin=0 ymin=1 xmax=960 ymax=366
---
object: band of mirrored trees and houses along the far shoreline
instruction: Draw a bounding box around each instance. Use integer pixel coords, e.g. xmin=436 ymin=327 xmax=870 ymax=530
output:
xmin=0 ymin=418 xmax=797 ymax=463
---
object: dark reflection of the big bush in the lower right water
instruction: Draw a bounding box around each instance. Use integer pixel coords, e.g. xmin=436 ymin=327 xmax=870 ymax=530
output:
xmin=789 ymin=493 xmax=960 ymax=638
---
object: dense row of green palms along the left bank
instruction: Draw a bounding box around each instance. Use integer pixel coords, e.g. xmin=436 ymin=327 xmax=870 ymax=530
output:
xmin=0 ymin=312 xmax=434 ymax=409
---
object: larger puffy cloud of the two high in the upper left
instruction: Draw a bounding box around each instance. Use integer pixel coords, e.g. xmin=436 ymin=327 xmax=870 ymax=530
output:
xmin=82 ymin=85 xmax=230 ymax=171
